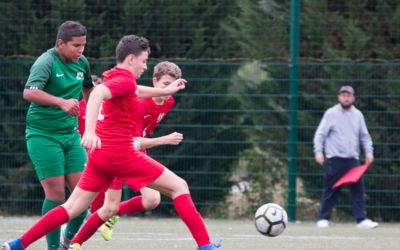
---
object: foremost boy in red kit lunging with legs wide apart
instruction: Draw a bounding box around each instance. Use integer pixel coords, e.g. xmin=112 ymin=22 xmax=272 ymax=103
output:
xmin=2 ymin=35 xmax=220 ymax=250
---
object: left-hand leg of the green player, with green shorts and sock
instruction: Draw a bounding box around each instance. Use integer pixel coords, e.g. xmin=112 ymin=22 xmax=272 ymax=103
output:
xmin=26 ymin=136 xmax=65 ymax=250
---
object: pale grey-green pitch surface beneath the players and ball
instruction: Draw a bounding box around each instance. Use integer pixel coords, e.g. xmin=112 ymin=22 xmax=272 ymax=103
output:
xmin=0 ymin=217 xmax=400 ymax=250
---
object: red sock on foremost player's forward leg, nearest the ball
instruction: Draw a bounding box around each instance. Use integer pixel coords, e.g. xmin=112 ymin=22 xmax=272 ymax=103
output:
xmin=173 ymin=194 xmax=210 ymax=246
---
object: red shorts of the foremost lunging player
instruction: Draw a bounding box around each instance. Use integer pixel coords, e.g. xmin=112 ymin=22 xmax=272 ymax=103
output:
xmin=78 ymin=149 xmax=165 ymax=192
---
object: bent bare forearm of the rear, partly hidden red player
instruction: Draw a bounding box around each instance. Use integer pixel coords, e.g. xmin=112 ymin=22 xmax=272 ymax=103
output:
xmin=133 ymin=132 xmax=183 ymax=149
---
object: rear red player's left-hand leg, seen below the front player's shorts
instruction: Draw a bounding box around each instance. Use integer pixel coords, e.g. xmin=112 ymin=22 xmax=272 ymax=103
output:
xmin=71 ymin=189 xmax=122 ymax=246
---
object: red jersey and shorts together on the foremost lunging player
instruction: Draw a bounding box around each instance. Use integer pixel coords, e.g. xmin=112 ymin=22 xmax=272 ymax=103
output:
xmin=78 ymin=67 xmax=165 ymax=192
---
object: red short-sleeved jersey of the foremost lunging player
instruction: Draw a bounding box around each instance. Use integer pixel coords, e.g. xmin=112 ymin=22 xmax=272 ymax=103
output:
xmin=96 ymin=67 xmax=140 ymax=153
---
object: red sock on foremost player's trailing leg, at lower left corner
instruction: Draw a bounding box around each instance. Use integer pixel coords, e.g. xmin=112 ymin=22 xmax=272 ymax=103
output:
xmin=21 ymin=206 xmax=69 ymax=248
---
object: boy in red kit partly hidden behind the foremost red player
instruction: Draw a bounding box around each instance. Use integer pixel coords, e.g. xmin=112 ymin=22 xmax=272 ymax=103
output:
xmin=87 ymin=61 xmax=183 ymax=242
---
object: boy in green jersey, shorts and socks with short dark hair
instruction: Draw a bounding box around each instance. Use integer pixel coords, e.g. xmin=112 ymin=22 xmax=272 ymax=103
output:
xmin=23 ymin=21 xmax=93 ymax=250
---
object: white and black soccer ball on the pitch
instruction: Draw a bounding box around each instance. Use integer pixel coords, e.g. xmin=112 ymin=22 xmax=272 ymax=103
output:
xmin=254 ymin=203 xmax=288 ymax=237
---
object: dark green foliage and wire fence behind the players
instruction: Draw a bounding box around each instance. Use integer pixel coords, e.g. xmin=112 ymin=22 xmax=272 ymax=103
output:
xmin=0 ymin=0 xmax=400 ymax=221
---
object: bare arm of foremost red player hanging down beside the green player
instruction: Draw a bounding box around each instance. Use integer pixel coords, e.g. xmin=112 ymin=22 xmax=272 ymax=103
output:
xmin=81 ymin=84 xmax=112 ymax=152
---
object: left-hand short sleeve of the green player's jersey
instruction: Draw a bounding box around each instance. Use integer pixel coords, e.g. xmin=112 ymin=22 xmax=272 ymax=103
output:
xmin=25 ymin=52 xmax=54 ymax=89
